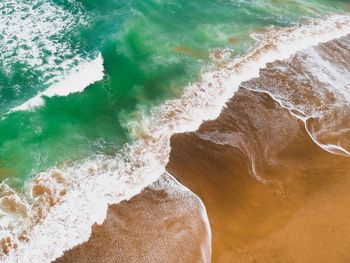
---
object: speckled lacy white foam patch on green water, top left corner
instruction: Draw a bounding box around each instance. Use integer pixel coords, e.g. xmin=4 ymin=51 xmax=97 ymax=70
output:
xmin=0 ymin=0 xmax=86 ymax=74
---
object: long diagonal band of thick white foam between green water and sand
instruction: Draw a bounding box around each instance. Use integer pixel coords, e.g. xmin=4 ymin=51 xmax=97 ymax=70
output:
xmin=0 ymin=15 xmax=350 ymax=262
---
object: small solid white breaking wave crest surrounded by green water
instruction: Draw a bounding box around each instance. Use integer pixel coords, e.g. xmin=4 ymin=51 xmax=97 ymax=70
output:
xmin=10 ymin=54 xmax=104 ymax=112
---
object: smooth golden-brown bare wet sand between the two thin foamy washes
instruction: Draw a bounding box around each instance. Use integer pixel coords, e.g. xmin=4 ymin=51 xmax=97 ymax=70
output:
xmin=168 ymin=89 xmax=350 ymax=263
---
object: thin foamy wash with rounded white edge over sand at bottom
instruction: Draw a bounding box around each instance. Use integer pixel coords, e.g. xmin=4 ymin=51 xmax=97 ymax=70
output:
xmin=55 ymin=175 xmax=211 ymax=263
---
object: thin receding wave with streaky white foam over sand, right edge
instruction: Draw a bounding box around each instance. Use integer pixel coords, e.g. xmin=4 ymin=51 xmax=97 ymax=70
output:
xmin=242 ymin=36 xmax=350 ymax=156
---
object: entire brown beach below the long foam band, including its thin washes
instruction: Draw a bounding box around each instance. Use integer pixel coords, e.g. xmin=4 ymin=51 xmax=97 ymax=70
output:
xmin=56 ymin=36 xmax=350 ymax=263
